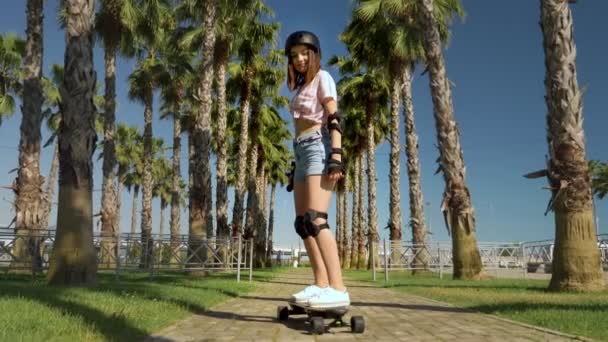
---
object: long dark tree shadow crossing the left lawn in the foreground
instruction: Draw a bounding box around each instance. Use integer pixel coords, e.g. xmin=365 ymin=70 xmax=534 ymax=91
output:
xmin=0 ymin=281 xmax=147 ymax=341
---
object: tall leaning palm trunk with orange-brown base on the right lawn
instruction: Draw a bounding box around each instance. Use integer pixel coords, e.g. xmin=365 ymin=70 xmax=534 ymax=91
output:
xmin=419 ymin=0 xmax=482 ymax=279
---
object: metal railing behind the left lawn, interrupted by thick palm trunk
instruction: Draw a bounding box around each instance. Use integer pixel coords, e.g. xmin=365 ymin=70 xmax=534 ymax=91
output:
xmin=0 ymin=228 xmax=253 ymax=281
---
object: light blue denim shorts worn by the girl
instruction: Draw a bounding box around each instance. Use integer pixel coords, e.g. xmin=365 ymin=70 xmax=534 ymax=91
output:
xmin=293 ymin=130 xmax=331 ymax=182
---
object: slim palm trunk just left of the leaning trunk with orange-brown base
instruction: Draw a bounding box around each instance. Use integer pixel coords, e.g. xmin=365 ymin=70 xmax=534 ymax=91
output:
xmin=402 ymin=65 xmax=430 ymax=272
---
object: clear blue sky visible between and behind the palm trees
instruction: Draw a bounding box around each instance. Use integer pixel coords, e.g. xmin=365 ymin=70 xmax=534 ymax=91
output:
xmin=0 ymin=0 xmax=608 ymax=247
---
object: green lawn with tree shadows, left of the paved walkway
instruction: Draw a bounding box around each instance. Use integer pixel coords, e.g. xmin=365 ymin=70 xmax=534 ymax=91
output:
xmin=0 ymin=269 xmax=282 ymax=341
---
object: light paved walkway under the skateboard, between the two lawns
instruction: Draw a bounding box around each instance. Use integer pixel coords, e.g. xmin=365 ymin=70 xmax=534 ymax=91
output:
xmin=146 ymin=269 xmax=588 ymax=342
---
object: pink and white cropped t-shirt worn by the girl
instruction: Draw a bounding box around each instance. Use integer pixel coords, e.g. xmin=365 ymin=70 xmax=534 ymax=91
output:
xmin=289 ymin=70 xmax=338 ymax=124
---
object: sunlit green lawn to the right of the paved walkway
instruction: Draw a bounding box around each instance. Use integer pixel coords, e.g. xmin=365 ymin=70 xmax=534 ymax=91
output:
xmin=345 ymin=271 xmax=608 ymax=341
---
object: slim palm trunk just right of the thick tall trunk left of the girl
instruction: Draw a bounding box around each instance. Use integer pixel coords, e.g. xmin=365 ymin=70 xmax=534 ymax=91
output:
xmin=215 ymin=40 xmax=230 ymax=239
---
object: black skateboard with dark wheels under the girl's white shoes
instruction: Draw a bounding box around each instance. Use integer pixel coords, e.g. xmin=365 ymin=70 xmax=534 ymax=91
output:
xmin=277 ymin=302 xmax=365 ymax=335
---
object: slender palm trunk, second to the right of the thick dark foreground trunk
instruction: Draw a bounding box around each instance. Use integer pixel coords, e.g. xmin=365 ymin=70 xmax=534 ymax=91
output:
xmin=140 ymin=89 xmax=154 ymax=268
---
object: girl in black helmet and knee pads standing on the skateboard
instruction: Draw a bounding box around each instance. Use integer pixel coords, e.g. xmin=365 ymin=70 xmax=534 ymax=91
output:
xmin=285 ymin=31 xmax=350 ymax=308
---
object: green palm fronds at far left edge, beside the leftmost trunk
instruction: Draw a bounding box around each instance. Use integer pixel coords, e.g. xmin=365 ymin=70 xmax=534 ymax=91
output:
xmin=0 ymin=33 xmax=25 ymax=125
